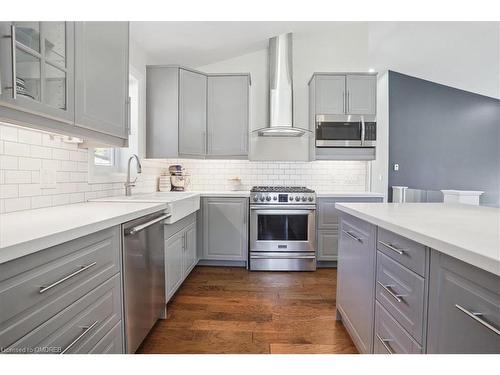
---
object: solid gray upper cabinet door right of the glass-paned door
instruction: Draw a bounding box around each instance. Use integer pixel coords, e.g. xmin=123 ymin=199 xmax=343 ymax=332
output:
xmin=75 ymin=22 xmax=129 ymax=139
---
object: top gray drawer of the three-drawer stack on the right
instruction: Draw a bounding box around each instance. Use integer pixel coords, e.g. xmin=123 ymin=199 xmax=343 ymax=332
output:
xmin=377 ymin=227 xmax=426 ymax=276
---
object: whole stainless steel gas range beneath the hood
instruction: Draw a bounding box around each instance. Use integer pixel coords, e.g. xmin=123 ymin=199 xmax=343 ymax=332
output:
xmin=250 ymin=186 xmax=316 ymax=271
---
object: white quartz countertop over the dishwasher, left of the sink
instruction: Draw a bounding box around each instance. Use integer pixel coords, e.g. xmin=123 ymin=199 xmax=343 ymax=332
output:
xmin=0 ymin=202 xmax=167 ymax=264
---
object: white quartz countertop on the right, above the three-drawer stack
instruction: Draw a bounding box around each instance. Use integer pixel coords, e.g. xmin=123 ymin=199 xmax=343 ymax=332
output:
xmin=335 ymin=203 xmax=500 ymax=276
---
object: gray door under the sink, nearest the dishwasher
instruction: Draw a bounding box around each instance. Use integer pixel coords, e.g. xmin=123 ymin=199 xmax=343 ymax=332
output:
xmin=165 ymin=231 xmax=184 ymax=302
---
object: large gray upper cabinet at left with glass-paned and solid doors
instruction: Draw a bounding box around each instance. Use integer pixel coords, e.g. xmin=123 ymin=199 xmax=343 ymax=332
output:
xmin=0 ymin=22 xmax=129 ymax=147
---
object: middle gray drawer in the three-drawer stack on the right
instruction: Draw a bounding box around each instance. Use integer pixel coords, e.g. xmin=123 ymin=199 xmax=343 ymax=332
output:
xmin=376 ymin=251 xmax=424 ymax=343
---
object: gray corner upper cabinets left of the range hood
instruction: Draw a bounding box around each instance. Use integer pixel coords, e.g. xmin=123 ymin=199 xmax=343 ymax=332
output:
xmin=146 ymin=66 xmax=250 ymax=159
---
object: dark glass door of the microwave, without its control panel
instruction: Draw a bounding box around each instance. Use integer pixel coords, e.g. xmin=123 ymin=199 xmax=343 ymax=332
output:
xmin=316 ymin=115 xmax=364 ymax=147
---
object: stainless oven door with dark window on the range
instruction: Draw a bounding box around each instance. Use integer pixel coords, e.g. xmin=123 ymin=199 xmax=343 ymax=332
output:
xmin=250 ymin=205 xmax=316 ymax=253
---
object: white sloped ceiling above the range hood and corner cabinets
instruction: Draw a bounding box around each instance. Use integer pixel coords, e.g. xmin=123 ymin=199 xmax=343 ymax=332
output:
xmin=131 ymin=21 xmax=364 ymax=67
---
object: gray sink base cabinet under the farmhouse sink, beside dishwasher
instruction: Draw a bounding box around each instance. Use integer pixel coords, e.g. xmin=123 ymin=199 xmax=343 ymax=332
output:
xmin=165 ymin=214 xmax=198 ymax=302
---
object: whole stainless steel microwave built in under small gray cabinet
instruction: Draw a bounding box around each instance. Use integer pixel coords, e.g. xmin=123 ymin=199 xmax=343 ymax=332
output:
xmin=316 ymin=115 xmax=377 ymax=147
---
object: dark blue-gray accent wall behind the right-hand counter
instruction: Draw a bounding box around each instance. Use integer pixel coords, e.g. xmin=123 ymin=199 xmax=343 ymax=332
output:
xmin=389 ymin=71 xmax=500 ymax=207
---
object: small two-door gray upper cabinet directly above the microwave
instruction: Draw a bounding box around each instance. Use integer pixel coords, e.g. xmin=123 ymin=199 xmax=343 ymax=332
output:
xmin=310 ymin=73 xmax=377 ymax=115
